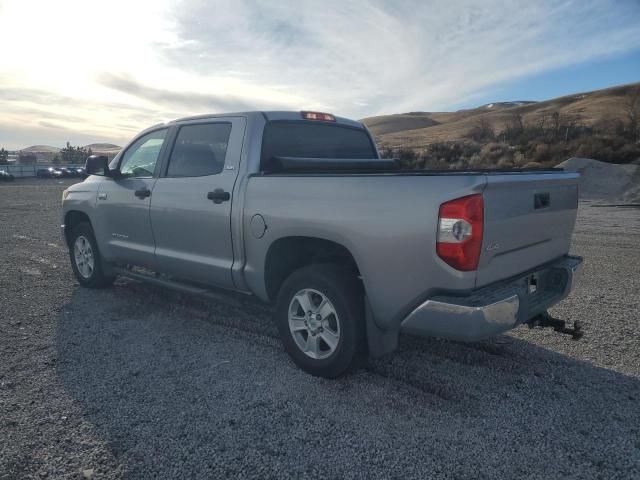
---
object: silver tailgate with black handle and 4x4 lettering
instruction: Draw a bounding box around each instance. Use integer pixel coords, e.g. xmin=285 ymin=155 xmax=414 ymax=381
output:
xmin=476 ymin=172 xmax=578 ymax=287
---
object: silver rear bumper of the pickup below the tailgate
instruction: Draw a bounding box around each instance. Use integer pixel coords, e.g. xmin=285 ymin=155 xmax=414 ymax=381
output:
xmin=400 ymin=256 xmax=582 ymax=342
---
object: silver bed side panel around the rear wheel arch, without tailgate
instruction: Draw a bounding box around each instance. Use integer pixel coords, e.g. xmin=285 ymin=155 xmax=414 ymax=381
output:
xmin=243 ymin=175 xmax=486 ymax=328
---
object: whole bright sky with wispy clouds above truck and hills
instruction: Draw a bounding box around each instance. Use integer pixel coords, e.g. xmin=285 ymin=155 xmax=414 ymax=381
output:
xmin=0 ymin=0 xmax=640 ymax=149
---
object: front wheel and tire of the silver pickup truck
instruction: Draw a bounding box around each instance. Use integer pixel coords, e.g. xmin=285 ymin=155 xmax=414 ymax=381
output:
xmin=69 ymin=222 xmax=115 ymax=288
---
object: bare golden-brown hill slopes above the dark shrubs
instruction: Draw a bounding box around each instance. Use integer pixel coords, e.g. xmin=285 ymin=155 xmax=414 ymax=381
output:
xmin=362 ymin=83 xmax=640 ymax=149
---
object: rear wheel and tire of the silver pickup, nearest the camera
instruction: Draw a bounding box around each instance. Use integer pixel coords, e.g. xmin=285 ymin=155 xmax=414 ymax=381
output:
xmin=275 ymin=264 xmax=365 ymax=378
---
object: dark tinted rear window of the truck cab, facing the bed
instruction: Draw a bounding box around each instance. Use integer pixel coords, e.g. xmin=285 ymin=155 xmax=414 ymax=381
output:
xmin=260 ymin=120 xmax=378 ymax=171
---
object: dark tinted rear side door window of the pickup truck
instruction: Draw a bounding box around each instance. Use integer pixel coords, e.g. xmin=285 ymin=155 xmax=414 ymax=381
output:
xmin=166 ymin=123 xmax=231 ymax=177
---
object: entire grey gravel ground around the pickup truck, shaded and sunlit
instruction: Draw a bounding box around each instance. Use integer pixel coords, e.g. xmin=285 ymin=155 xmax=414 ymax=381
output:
xmin=0 ymin=180 xmax=640 ymax=479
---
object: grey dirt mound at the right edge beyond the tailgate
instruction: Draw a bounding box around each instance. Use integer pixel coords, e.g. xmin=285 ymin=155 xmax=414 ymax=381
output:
xmin=558 ymin=157 xmax=640 ymax=203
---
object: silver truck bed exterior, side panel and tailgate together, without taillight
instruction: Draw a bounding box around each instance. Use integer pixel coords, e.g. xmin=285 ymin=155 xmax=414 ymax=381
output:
xmin=244 ymin=169 xmax=578 ymax=328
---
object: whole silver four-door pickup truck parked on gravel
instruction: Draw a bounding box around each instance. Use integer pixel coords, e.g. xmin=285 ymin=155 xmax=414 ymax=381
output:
xmin=62 ymin=112 xmax=582 ymax=377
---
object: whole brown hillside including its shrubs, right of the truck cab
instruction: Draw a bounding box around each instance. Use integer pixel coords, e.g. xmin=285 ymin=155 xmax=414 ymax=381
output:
xmin=363 ymin=83 xmax=640 ymax=173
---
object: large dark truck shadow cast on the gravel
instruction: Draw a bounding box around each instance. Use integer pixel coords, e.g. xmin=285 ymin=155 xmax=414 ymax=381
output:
xmin=57 ymin=281 xmax=640 ymax=478
